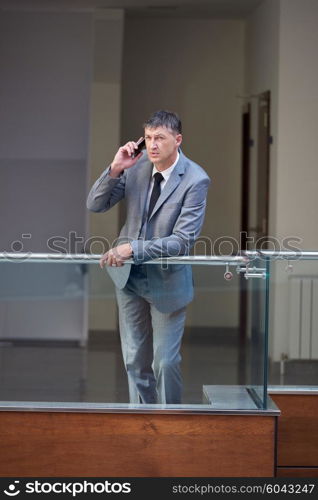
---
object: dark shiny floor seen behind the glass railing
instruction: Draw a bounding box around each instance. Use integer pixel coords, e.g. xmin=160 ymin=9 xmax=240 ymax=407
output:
xmin=0 ymin=328 xmax=318 ymax=404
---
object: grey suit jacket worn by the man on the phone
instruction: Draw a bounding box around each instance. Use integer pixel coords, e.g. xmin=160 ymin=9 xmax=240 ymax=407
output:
xmin=87 ymin=151 xmax=210 ymax=312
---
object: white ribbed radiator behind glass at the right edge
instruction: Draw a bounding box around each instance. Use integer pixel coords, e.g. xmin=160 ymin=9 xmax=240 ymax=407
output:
xmin=288 ymin=275 xmax=318 ymax=359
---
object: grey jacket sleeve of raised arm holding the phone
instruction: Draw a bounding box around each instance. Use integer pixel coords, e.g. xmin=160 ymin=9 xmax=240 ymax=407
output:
xmin=86 ymin=167 xmax=126 ymax=212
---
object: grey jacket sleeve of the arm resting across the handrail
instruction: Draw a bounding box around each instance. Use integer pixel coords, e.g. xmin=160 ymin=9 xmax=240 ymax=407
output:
xmin=130 ymin=177 xmax=210 ymax=264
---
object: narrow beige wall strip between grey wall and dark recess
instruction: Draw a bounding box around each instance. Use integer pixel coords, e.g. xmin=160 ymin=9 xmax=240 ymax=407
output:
xmin=88 ymin=9 xmax=124 ymax=330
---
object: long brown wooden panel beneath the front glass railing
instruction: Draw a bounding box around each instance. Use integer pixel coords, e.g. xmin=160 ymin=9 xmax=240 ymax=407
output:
xmin=0 ymin=412 xmax=275 ymax=477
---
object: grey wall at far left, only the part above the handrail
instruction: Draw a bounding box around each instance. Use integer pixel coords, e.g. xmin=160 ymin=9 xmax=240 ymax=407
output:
xmin=0 ymin=12 xmax=92 ymax=252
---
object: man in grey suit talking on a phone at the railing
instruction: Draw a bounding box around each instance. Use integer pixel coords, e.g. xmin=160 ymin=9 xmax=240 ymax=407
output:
xmin=87 ymin=111 xmax=210 ymax=404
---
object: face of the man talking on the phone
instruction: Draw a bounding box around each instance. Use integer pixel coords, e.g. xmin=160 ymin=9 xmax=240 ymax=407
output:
xmin=145 ymin=127 xmax=182 ymax=169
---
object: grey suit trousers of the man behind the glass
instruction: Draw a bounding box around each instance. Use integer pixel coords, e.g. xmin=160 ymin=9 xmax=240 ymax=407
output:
xmin=116 ymin=265 xmax=186 ymax=404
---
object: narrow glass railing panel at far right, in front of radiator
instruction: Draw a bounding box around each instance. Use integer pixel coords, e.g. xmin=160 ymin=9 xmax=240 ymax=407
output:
xmin=269 ymin=252 xmax=318 ymax=388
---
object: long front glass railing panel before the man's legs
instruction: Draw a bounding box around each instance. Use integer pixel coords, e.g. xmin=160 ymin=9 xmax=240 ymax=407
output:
xmin=0 ymin=254 xmax=267 ymax=411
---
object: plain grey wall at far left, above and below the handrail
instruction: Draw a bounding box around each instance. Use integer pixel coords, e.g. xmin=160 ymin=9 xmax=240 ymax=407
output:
xmin=0 ymin=11 xmax=92 ymax=342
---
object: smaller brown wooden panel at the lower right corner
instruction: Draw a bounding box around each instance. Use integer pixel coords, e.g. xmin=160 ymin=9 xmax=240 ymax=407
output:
xmin=271 ymin=394 xmax=318 ymax=467
